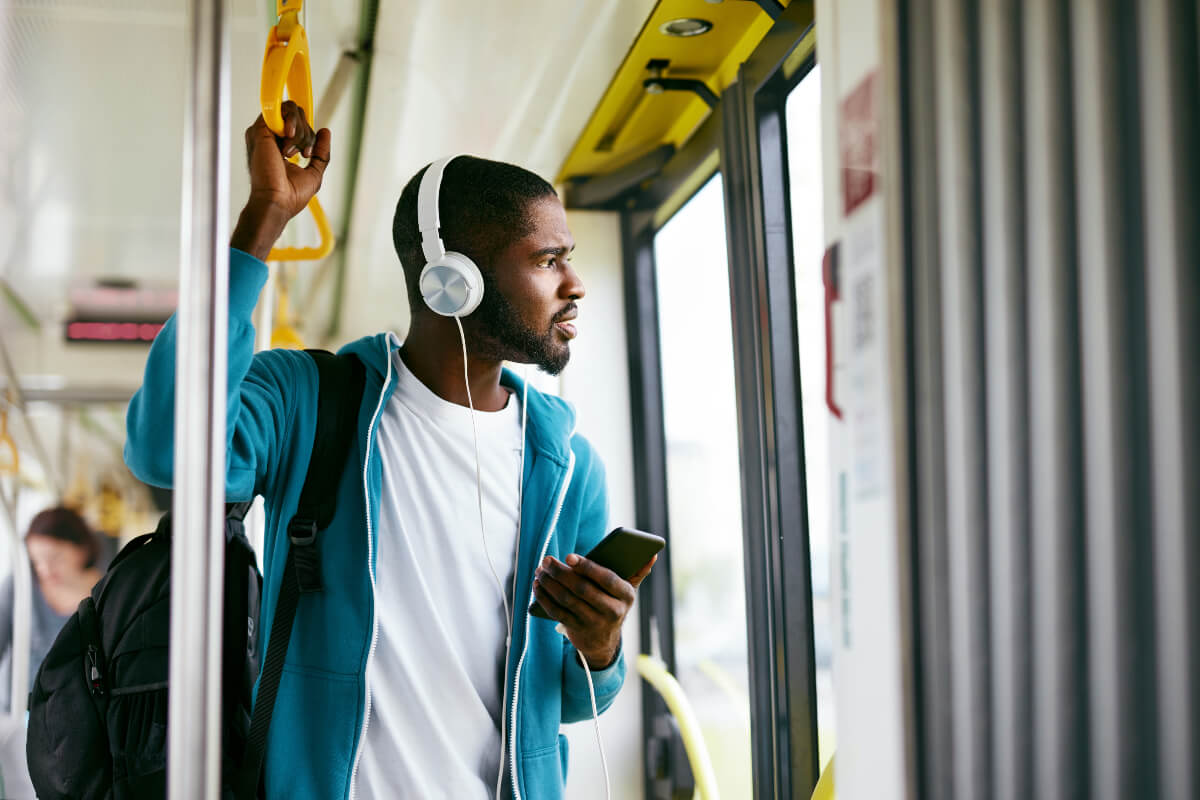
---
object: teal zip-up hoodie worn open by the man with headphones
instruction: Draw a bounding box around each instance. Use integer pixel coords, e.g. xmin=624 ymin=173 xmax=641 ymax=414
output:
xmin=125 ymin=249 xmax=625 ymax=800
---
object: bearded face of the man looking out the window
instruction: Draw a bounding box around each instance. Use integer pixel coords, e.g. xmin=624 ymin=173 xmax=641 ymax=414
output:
xmin=463 ymin=196 xmax=583 ymax=375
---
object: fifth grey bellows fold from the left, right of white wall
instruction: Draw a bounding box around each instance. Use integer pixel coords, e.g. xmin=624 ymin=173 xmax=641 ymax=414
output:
xmin=1070 ymin=0 xmax=1154 ymax=800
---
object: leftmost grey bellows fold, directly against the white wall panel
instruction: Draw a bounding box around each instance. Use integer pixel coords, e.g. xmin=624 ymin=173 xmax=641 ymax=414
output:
xmin=902 ymin=0 xmax=954 ymax=800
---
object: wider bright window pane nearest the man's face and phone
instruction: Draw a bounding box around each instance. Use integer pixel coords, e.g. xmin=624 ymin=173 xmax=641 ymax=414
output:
xmin=654 ymin=175 xmax=752 ymax=798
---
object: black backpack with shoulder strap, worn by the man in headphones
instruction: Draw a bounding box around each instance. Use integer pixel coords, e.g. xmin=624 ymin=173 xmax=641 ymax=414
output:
xmin=25 ymin=350 xmax=364 ymax=800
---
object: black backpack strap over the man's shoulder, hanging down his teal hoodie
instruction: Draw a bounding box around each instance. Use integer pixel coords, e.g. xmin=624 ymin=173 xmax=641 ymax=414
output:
xmin=236 ymin=350 xmax=366 ymax=800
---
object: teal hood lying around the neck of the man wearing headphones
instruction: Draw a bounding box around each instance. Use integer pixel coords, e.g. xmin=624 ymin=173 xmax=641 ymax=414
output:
xmin=338 ymin=332 xmax=575 ymax=465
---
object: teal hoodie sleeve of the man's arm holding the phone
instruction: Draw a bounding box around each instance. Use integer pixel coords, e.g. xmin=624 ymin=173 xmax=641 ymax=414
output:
xmin=563 ymin=443 xmax=625 ymax=722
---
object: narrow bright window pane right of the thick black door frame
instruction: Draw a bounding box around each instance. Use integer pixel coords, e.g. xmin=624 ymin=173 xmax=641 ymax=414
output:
xmin=785 ymin=66 xmax=835 ymax=766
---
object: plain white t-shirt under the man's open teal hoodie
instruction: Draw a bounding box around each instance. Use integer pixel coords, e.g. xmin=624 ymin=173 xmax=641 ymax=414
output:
xmin=355 ymin=351 xmax=521 ymax=800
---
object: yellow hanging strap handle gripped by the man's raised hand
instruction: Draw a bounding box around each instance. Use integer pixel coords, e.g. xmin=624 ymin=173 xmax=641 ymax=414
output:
xmin=259 ymin=0 xmax=334 ymax=261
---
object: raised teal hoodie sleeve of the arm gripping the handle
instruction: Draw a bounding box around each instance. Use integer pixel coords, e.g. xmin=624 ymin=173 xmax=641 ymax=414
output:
xmin=125 ymin=248 xmax=298 ymax=501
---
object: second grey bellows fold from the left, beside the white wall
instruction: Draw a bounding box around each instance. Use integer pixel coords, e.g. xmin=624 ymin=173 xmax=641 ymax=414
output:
xmin=934 ymin=0 xmax=991 ymax=800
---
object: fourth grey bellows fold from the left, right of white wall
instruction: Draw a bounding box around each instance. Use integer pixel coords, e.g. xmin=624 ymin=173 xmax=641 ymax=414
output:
xmin=1021 ymin=0 xmax=1087 ymax=800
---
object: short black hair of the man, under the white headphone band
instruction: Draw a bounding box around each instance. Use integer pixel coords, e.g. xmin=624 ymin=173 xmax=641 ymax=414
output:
xmin=391 ymin=156 xmax=558 ymax=311
